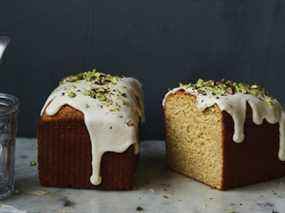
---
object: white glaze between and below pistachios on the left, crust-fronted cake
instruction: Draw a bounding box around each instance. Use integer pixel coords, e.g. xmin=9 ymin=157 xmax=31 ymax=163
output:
xmin=41 ymin=78 xmax=144 ymax=185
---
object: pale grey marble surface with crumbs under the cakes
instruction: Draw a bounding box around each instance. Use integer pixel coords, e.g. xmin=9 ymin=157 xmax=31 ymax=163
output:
xmin=0 ymin=138 xmax=285 ymax=213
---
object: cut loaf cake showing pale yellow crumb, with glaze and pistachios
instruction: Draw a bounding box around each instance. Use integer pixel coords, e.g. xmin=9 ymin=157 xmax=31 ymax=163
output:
xmin=163 ymin=79 xmax=285 ymax=190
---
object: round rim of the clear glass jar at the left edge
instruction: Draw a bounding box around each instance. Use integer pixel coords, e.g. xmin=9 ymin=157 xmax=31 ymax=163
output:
xmin=0 ymin=93 xmax=20 ymax=116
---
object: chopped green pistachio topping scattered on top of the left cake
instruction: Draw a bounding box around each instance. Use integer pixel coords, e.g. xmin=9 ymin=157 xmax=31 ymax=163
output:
xmin=45 ymin=69 xmax=140 ymax=112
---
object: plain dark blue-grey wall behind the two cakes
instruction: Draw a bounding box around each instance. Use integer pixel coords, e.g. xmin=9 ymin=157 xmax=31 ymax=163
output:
xmin=0 ymin=0 xmax=285 ymax=139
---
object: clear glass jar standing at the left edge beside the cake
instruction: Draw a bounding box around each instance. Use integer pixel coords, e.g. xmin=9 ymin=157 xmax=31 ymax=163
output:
xmin=0 ymin=93 xmax=19 ymax=199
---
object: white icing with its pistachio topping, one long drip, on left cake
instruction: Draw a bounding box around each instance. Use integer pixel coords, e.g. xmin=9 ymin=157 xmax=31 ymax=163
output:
xmin=41 ymin=70 xmax=144 ymax=185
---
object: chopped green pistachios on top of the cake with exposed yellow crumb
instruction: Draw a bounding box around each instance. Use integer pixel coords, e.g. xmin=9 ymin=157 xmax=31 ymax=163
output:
xmin=179 ymin=79 xmax=273 ymax=105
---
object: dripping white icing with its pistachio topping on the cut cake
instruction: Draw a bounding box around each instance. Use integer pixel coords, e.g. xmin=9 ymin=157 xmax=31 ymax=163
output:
xmin=162 ymin=79 xmax=285 ymax=161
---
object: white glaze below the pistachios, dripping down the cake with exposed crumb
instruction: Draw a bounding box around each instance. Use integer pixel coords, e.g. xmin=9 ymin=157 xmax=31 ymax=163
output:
xmin=162 ymin=87 xmax=285 ymax=161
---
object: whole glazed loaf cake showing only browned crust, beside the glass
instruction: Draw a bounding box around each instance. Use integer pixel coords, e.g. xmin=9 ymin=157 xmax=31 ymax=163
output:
xmin=37 ymin=70 xmax=144 ymax=190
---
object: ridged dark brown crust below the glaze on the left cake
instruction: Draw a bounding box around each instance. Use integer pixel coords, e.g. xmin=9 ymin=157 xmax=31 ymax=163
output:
xmin=38 ymin=105 xmax=138 ymax=190
